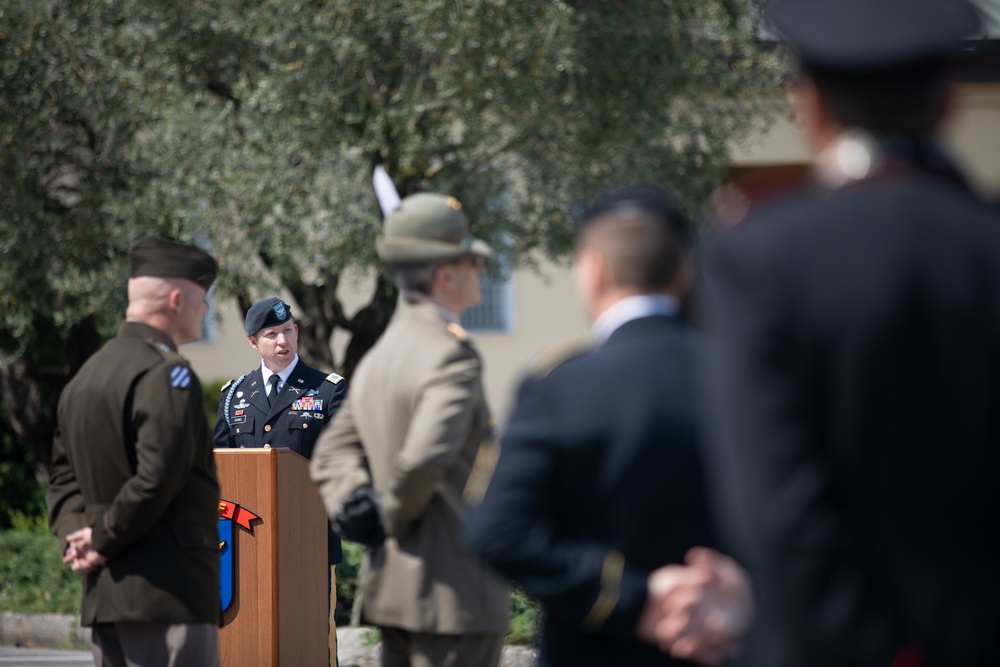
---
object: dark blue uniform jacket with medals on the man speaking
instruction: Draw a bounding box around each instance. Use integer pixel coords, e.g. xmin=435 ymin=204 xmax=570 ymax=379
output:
xmin=212 ymin=358 xmax=347 ymax=563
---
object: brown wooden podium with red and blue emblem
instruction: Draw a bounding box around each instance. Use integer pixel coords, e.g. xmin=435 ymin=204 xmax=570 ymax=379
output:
xmin=215 ymin=448 xmax=329 ymax=667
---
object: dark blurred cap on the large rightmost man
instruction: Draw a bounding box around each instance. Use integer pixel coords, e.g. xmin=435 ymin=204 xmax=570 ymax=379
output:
xmin=767 ymin=0 xmax=981 ymax=71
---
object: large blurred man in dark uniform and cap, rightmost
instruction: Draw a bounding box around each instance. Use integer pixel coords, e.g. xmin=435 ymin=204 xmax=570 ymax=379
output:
xmin=706 ymin=0 xmax=1000 ymax=667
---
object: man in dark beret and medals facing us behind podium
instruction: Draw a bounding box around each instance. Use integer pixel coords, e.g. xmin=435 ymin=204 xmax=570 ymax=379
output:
xmin=212 ymin=297 xmax=347 ymax=664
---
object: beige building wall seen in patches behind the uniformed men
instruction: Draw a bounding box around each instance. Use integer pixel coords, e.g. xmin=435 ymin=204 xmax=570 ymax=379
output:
xmin=182 ymin=84 xmax=1000 ymax=420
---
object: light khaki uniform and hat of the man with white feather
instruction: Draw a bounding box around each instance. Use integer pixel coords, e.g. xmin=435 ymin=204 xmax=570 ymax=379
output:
xmin=312 ymin=194 xmax=509 ymax=667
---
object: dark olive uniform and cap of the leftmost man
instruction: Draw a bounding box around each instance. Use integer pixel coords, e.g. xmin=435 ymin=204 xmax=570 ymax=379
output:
xmin=46 ymin=239 xmax=219 ymax=667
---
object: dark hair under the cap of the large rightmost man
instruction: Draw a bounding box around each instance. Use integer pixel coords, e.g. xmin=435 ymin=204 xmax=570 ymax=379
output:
xmin=803 ymin=61 xmax=951 ymax=136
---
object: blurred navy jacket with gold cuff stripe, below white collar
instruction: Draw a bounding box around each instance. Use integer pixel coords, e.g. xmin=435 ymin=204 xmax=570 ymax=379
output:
xmin=468 ymin=316 xmax=714 ymax=667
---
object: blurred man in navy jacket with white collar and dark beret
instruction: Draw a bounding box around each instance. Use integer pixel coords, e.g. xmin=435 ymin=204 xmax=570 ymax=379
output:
xmin=468 ymin=186 xmax=750 ymax=667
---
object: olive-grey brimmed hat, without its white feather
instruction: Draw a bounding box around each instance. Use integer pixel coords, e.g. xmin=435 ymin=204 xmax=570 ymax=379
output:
xmin=375 ymin=193 xmax=493 ymax=264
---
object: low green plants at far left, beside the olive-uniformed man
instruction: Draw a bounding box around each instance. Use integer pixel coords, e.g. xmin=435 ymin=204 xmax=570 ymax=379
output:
xmin=0 ymin=530 xmax=83 ymax=614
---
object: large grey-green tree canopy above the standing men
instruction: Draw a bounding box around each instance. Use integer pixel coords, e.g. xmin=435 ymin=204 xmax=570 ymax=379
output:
xmin=0 ymin=0 xmax=777 ymax=376
